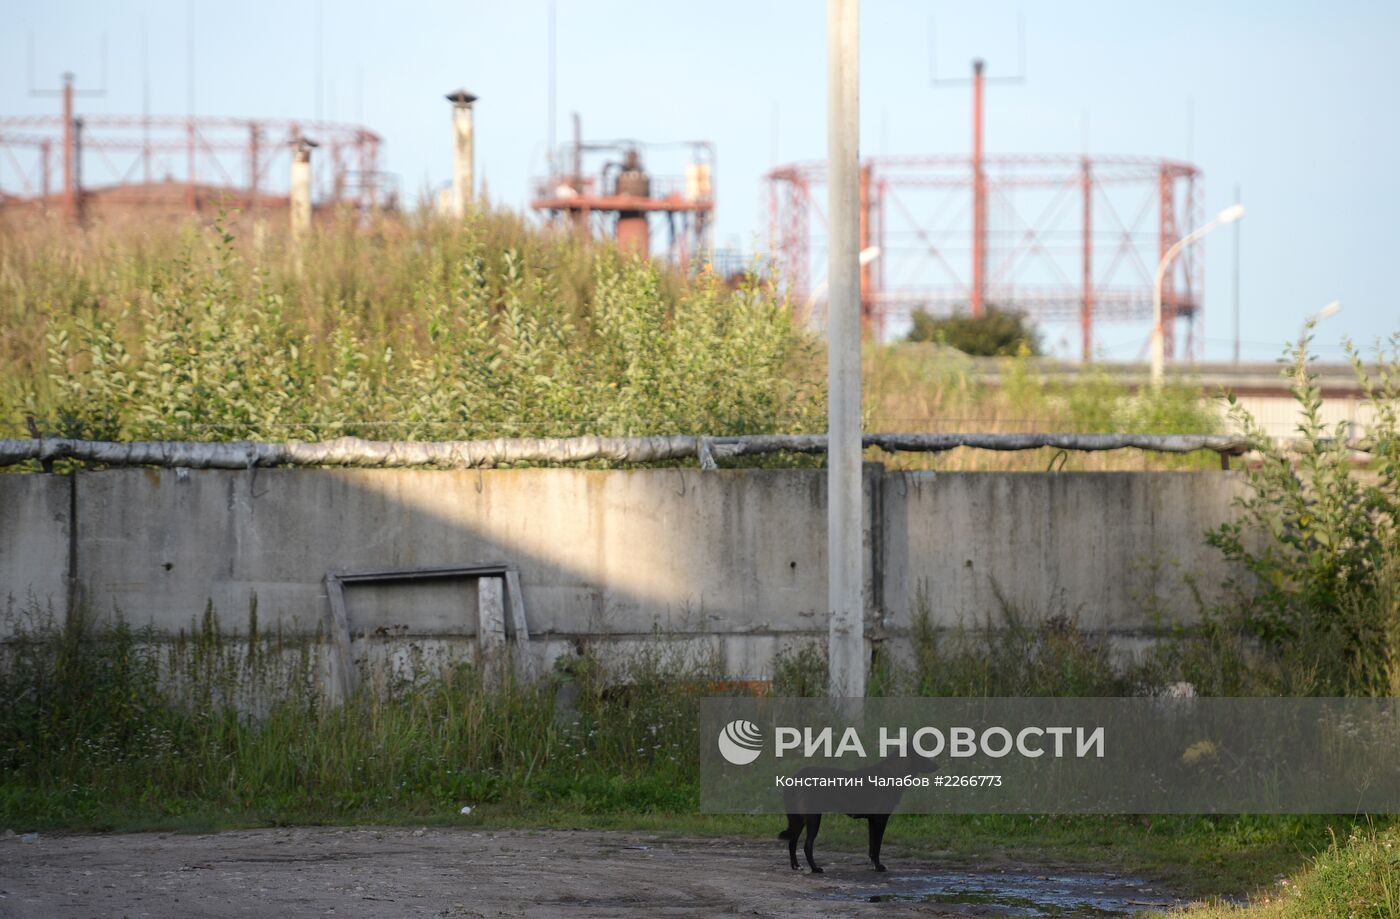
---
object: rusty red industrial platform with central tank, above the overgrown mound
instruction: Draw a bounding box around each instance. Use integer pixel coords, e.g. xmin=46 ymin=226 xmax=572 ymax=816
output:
xmin=531 ymin=115 xmax=714 ymax=270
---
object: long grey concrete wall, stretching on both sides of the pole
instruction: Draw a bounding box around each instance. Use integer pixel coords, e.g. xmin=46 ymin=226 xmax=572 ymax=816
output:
xmin=0 ymin=467 xmax=1240 ymax=677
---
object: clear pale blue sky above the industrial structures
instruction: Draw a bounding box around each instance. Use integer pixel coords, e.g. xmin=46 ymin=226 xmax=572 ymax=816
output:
xmin=0 ymin=0 xmax=1400 ymax=360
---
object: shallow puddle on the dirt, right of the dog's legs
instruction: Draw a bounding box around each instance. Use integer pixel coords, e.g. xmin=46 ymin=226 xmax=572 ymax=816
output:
xmin=829 ymin=870 xmax=1204 ymax=916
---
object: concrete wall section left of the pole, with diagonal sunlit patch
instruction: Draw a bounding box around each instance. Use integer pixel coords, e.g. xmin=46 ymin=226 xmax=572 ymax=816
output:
xmin=0 ymin=469 xmax=826 ymax=674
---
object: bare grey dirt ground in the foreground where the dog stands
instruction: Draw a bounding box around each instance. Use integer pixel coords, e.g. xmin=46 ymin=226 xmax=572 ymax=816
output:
xmin=0 ymin=828 xmax=1192 ymax=919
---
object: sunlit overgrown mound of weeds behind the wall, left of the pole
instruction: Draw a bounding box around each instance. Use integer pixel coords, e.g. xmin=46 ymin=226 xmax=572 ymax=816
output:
xmin=0 ymin=214 xmax=823 ymax=440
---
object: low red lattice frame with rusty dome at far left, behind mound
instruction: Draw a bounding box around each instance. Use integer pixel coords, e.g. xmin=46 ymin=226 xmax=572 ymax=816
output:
xmin=0 ymin=74 xmax=398 ymax=220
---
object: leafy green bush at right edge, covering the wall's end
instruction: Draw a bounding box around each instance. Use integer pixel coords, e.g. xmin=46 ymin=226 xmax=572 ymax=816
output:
xmin=1208 ymin=326 xmax=1400 ymax=695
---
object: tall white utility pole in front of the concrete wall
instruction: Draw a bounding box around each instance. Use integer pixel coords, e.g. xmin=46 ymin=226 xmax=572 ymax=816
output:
xmin=826 ymin=0 xmax=865 ymax=698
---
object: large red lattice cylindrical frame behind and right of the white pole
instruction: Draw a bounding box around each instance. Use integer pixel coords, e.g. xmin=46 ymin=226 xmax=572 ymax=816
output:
xmin=767 ymin=62 xmax=1204 ymax=360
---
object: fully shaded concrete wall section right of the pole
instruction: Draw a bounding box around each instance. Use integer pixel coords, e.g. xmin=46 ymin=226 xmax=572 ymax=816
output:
xmin=882 ymin=472 xmax=1242 ymax=633
